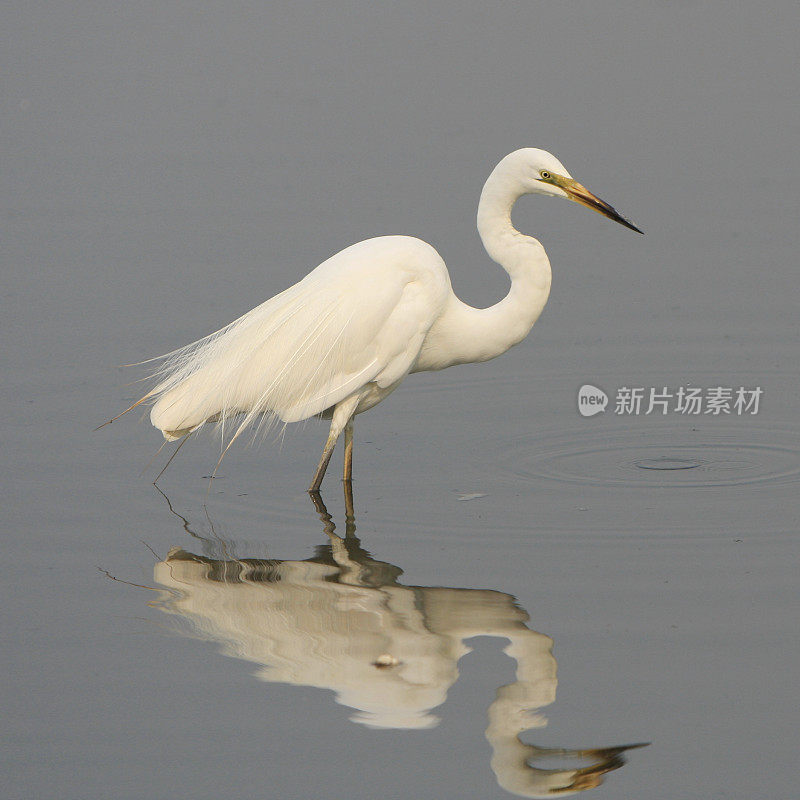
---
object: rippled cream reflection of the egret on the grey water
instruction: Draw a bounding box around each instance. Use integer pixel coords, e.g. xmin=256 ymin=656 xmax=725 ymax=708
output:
xmin=150 ymin=495 xmax=648 ymax=797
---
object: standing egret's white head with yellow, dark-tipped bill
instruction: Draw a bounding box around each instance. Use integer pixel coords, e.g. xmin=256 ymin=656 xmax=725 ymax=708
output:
xmin=512 ymin=147 xmax=643 ymax=233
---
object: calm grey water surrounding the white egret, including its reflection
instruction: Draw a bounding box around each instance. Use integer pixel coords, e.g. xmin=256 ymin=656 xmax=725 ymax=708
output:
xmin=0 ymin=0 xmax=800 ymax=800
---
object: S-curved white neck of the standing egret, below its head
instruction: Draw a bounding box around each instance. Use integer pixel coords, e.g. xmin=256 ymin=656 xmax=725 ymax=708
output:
xmin=417 ymin=161 xmax=551 ymax=370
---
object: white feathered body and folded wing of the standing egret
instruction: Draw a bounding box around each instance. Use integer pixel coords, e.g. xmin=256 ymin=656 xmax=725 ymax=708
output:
xmin=150 ymin=237 xmax=449 ymax=446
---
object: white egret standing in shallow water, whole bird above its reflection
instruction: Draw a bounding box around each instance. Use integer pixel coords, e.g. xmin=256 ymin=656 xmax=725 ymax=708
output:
xmin=109 ymin=148 xmax=642 ymax=491
